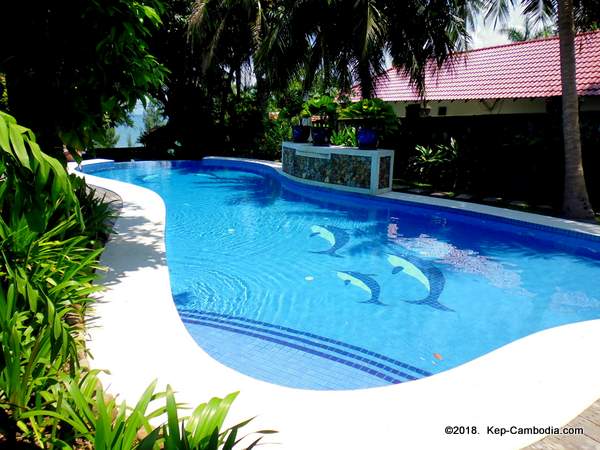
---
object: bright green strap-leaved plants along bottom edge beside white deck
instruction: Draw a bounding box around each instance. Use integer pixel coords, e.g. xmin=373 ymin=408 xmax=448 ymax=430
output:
xmin=21 ymin=371 xmax=274 ymax=450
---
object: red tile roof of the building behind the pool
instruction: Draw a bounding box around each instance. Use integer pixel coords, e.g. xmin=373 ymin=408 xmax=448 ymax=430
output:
xmin=355 ymin=31 xmax=600 ymax=101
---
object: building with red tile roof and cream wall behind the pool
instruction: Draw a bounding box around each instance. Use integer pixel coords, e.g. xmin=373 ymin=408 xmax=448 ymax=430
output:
xmin=357 ymin=31 xmax=600 ymax=117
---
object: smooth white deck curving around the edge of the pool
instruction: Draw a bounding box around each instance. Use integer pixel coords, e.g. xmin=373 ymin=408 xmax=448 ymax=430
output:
xmin=74 ymin=162 xmax=600 ymax=450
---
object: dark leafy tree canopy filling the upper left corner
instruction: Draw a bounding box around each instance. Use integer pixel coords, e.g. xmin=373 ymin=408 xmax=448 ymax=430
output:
xmin=0 ymin=0 xmax=166 ymax=149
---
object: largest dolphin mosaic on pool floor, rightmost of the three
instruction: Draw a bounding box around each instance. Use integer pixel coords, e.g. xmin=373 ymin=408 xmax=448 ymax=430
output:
xmin=388 ymin=255 xmax=454 ymax=311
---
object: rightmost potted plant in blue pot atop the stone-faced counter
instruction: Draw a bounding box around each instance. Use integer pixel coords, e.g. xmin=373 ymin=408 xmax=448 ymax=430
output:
xmin=340 ymin=98 xmax=398 ymax=149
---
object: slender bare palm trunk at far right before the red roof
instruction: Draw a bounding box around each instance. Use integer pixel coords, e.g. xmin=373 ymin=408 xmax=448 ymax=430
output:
xmin=558 ymin=0 xmax=594 ymax=219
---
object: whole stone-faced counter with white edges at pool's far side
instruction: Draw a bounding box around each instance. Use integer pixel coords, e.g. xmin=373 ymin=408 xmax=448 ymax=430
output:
xmin=281 ymin=142 xmax=394 ymax=194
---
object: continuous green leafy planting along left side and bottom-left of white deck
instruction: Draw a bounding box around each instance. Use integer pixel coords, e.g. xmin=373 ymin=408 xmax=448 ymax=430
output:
xmin=0 ymin=112 xmax=272 ymax=450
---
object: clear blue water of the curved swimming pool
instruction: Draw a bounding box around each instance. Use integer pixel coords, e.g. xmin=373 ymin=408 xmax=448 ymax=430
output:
xmin=86 ymin=160 xmax=600 ymax=389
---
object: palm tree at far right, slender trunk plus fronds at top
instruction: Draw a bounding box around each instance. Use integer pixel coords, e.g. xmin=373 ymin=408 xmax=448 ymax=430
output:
xmin=486 ymin=0 xmax=600 ymax=220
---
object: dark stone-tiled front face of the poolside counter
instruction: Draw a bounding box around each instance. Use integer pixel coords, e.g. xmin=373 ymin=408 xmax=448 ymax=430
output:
xmin=282 ymin=146 xmax=370 ymax=189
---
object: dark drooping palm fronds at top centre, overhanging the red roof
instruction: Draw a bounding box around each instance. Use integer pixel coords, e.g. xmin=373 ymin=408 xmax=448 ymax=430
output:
xmin=257 ymin=0 xmax=470 ymax=97
